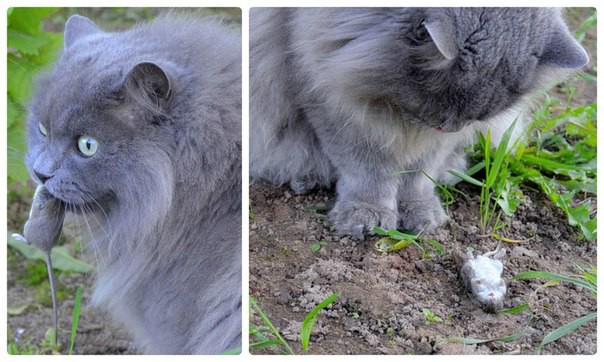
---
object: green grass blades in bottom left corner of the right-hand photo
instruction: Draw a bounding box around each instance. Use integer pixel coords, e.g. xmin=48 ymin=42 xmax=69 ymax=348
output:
xmin=249 ymin=293 xmax=338 ymax=355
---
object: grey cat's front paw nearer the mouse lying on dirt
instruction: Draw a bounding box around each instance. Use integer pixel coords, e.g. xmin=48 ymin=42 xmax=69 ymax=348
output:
xmin=399 ymin=197 xmax=449 ymax=233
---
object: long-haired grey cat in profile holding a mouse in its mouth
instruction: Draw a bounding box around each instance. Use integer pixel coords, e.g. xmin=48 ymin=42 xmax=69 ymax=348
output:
xmin=26 ymin=15 xmax=242 ymax=354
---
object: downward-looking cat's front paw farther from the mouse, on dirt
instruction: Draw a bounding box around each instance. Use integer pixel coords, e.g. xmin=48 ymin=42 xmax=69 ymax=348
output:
xmin=329 ymin=201 xmax=397 ymax=240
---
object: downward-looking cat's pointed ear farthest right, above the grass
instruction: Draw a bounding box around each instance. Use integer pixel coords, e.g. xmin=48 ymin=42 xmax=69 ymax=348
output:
xmin=540 ymin=27 xmax=589 ymax=68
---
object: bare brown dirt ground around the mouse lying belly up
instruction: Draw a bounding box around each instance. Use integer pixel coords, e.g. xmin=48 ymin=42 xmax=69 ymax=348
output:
xmin=249 ymin=10 xmax=597 ymax=354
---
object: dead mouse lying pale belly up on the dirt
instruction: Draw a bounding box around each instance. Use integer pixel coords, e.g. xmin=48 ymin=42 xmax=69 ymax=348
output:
xmin=453 ymin=246 xmax=507 ymax=313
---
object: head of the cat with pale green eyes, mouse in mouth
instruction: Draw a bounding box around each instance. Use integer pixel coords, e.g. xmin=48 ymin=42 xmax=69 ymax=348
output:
xmin=26 ymin=18 xmax=174 ymax=218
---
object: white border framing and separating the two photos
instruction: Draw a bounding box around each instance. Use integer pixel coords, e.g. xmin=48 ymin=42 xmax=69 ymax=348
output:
xmin=0 ymin=0 xmax=604 ymax=362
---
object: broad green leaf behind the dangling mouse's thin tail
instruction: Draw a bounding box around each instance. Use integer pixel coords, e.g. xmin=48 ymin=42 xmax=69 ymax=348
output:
xmin=8 ymin=235 xmax=94 ymax=273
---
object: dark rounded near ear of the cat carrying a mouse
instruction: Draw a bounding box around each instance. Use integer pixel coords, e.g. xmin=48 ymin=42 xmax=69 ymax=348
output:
xmin=126 ymin=62 xmax=172 ymax=107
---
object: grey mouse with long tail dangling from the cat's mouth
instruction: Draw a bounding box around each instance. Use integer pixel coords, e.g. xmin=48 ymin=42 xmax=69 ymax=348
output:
xmin=13 ymin=185 xmax=66 ymax=344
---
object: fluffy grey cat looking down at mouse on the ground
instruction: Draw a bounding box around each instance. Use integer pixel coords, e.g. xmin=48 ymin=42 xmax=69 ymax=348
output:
xmin=250 ymin=8 xmax=588 ymax=238
